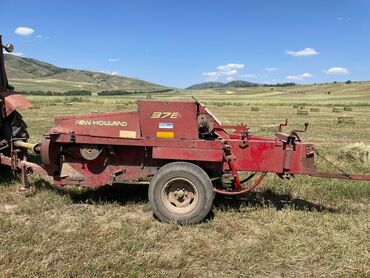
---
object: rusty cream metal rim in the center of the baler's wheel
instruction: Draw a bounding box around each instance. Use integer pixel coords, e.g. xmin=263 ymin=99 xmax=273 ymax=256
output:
xmin=161 ymin=178 xmax=199 ymax=214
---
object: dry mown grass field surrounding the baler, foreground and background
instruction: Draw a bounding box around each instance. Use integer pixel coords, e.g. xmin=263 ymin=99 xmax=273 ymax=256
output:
xmin=0 ymin=82 xmax=370 ymax=277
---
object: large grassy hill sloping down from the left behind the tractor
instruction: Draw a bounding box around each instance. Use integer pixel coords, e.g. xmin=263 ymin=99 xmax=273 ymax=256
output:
xmin=4 ymin=54 xmax=168 ymax=91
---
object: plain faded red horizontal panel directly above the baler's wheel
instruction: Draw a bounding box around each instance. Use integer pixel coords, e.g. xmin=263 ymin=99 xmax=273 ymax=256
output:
xmin=152 ymin=147 xmax=223 ymax=162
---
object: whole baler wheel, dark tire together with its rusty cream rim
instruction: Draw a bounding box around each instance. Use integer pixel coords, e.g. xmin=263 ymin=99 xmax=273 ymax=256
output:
xmin=148 ymin=162 xmax=215 ymax=225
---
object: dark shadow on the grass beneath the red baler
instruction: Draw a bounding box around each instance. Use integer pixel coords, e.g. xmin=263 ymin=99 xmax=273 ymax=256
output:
xmin=29 ymin=179 xmax=338 ymax=213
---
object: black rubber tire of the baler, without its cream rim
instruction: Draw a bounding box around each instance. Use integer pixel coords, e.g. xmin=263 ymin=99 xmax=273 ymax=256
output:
xmin=148 ymin=162 xmax=215 ymax=225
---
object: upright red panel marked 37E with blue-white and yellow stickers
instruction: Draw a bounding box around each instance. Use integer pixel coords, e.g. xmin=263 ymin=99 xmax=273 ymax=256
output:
xmin=138 ymin=100 xmax=199 ymax=139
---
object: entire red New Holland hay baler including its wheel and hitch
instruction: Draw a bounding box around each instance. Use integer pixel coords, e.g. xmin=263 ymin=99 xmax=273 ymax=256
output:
xmin=0 ymin=37 xmax=370 ymax=224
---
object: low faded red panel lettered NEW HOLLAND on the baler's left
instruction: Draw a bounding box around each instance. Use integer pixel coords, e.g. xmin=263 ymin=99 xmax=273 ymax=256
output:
xmin=54 ymin=111 xmax=140 ymax=139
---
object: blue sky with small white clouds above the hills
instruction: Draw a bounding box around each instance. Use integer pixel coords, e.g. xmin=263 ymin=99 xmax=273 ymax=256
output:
xmin=0 ymin=0 xmax=370 ymax=87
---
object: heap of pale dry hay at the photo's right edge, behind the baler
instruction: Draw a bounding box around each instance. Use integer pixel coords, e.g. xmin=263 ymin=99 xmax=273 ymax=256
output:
xmin=338 ymin=142 xmax=370 ymax=163
